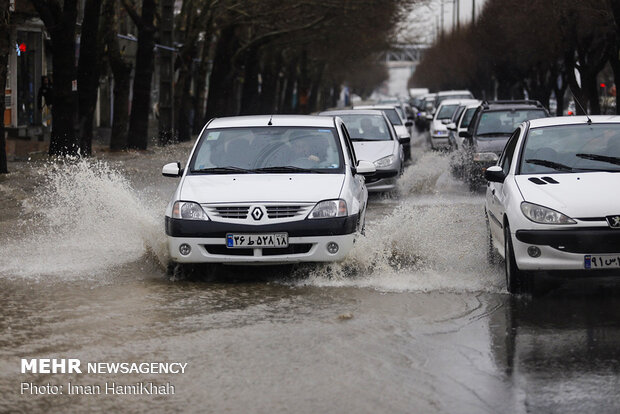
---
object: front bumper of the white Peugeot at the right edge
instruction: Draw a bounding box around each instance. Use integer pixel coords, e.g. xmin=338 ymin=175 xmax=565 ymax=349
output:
xmin=513 ymin=227 xmax=620 ymax=275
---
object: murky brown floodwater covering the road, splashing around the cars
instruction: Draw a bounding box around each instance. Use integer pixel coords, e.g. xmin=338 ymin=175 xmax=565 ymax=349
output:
xmin=0 ymin=135 xmax=620 ymax=413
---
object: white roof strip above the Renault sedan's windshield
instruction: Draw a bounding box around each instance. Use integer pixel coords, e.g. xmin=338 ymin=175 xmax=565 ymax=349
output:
xmin=208 ymin=115 xmax=335 ymax=129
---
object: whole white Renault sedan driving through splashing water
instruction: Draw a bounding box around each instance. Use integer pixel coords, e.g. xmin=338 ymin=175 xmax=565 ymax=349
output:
xmin=162 ymin=115 xmax=375 ymax=264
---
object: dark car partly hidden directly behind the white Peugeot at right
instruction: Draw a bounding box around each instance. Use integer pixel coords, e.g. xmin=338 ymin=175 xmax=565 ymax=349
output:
xmin=459 ymin=100 xmax=549 ymax=190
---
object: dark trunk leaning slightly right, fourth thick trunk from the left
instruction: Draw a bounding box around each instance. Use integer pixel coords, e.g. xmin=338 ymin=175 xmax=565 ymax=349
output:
xmin=128 ymin=0 xmax=156 ymax=150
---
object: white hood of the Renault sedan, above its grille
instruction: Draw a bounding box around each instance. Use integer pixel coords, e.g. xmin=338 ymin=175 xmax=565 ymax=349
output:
xmin=178 ymin=174 xmax=345 ymax=203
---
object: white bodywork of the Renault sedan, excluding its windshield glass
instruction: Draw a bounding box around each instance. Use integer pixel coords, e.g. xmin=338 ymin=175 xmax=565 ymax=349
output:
xmin=162 ymin=115 xmax=375 ymax=264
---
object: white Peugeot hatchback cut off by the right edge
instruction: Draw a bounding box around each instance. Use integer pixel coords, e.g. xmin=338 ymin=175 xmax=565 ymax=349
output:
xmin=485 ymin=116 xmax=620 ymax=293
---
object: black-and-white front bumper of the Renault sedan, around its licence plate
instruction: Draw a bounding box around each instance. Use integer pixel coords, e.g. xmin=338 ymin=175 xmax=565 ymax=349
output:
xmin=166 ymin=215 xmax=358 ymax=264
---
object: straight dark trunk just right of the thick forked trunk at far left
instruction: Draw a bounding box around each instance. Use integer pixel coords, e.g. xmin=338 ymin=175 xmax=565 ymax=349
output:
xmin=78 ymin=0 xmax=101 ymax=156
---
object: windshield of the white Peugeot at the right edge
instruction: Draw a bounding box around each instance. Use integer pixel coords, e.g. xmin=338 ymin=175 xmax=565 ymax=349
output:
xmin=520 ymin=124 xmax=620 ymax=174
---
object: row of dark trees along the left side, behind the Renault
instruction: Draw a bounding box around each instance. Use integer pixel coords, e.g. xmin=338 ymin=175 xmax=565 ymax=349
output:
xmin=0 ymin=0 xmax=416 ymax=173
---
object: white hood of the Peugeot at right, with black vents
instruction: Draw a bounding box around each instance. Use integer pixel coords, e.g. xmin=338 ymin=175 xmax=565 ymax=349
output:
xmin=515 ymin=172 xmax=620 ymax=218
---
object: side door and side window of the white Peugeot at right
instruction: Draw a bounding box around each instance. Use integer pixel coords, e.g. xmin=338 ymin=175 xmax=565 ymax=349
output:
xmin=486 ymin=127 xmax=522 ymax=245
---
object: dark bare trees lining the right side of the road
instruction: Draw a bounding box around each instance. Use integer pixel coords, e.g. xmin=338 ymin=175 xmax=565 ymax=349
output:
xmin=410 ymin=0 xmax=620 ymax=114
